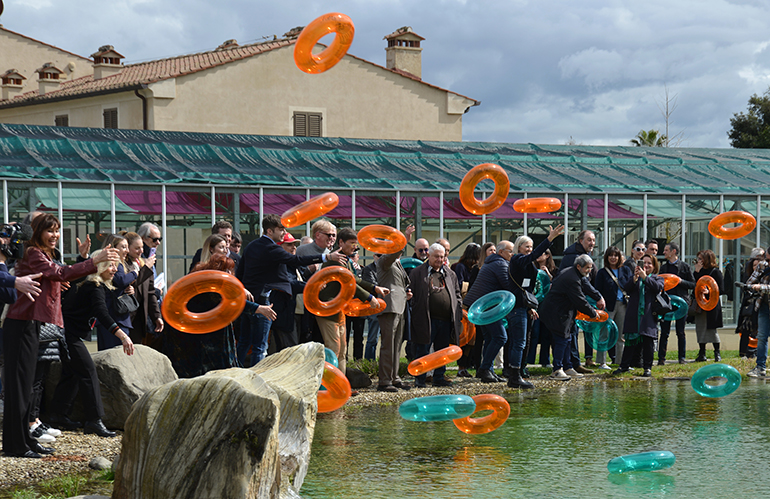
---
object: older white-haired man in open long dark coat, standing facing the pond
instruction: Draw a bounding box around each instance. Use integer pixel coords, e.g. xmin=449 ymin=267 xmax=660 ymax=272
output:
xmin=409 ymin=243 xmax=463 ymax=388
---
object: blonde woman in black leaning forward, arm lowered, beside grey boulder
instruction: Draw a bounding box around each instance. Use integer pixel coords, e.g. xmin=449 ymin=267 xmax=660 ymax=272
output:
xmin=51 ymin=250 xmax=134 ymax=437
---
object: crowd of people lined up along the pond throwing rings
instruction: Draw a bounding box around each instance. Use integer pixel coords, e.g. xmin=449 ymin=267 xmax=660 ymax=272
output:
xmin=0 ymin=212 xmax=770 ymax=458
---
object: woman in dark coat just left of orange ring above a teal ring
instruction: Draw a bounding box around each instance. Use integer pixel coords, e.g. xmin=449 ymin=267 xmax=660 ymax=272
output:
xmin=613 ymin=255 xmax=663 ymax=377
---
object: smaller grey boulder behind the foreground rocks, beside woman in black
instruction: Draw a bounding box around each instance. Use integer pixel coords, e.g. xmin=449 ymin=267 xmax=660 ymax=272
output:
xmin=91 ymin=345 xmax=178 ymax=430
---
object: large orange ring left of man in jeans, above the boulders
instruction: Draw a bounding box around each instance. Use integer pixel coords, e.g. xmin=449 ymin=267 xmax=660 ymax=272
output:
xmin=161 ymin=270 xmax=246 ymax=334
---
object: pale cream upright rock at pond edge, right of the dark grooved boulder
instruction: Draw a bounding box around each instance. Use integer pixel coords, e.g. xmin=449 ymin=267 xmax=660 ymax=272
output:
xmin=251 ymin=343 xmax=324 ymax=495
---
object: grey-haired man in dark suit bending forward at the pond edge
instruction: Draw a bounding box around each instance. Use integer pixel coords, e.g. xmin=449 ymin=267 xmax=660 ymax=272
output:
xmin=538 ymin=254 xmax=596 ymax=381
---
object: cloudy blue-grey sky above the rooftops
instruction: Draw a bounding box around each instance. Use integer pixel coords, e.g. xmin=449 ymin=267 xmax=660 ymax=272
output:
xmin=0 ymin=0 xmax=770 ymax=147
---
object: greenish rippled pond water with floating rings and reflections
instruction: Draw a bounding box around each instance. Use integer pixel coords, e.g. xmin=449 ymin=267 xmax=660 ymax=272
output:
xmin=300 ymin=379 xmax=770 ymax=499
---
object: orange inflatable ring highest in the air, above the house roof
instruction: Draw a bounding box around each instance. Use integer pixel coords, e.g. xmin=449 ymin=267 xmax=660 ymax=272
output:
xmin=294 ymin=12 xmax=356 ymax=74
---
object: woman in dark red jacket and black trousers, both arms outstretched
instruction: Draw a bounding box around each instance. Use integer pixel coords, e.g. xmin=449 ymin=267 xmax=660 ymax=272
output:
xmin=3 ymin=215 xmax=118 ymax=458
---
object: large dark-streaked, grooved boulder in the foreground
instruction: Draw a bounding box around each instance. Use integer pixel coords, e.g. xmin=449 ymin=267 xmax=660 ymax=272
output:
xmin=112 ymin=369 xmax=281 ymax=499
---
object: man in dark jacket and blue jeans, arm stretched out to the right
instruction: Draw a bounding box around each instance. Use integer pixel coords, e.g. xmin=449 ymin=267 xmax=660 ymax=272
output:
xmin=235 ymin=215 xmax=347 ymax=367
